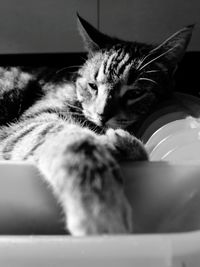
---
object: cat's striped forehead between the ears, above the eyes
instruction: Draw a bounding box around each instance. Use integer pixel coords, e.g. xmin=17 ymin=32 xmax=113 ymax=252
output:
xmin=81 ymin=43 xmax=150 ymax=83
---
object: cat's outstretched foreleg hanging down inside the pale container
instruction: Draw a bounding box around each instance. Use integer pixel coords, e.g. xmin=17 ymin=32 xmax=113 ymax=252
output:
xmin=34 ymin=125 xmax=132 ymax=236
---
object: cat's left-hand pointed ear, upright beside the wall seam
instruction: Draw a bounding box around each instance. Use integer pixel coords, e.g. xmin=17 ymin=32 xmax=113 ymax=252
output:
xmin=77 ymin=13 xmax=112 ymax=53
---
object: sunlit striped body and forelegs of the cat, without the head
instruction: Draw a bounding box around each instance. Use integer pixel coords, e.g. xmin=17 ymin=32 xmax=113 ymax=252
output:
xmin=0 ymin=66 xmax=147 ymax=235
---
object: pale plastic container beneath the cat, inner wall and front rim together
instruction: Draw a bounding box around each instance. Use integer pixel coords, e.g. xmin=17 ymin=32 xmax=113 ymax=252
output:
xmin=0 ymin=162 xmax=200 ymax=267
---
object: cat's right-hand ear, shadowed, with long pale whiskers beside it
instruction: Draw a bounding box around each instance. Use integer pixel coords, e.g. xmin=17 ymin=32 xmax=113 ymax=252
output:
xmin=154 ymin=25 xmax=194 ymax=67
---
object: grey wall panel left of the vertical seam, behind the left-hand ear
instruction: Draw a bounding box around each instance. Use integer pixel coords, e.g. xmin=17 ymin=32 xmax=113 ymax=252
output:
xmin=0 ymin=0 xmax=97 ymax=54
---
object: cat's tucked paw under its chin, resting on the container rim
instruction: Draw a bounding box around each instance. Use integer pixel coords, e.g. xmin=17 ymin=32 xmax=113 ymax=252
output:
xmin=106 ymin=129 xmax=148 ymax=161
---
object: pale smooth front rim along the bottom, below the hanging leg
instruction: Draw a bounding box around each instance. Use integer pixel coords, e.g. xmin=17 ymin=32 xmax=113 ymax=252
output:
xmin=0 ymin=232 xmax=200 ymax=267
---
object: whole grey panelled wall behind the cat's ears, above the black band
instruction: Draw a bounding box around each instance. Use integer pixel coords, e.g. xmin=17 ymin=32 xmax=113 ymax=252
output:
xmin=0 ymin=0 xmax=200 ymax=54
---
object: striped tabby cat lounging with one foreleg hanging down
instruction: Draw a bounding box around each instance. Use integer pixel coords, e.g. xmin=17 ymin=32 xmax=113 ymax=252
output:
xmin=0 ymin=15 xmax=193 ymax=236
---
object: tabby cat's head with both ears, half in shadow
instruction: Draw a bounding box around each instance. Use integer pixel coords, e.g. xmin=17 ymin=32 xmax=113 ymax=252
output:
xmin=76 ymin=16 xmax=193 ymax=128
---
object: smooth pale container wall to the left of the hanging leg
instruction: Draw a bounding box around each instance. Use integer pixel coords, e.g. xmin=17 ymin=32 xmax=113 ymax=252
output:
xmin=0 ymin=161 xmax=64 ymax=235
